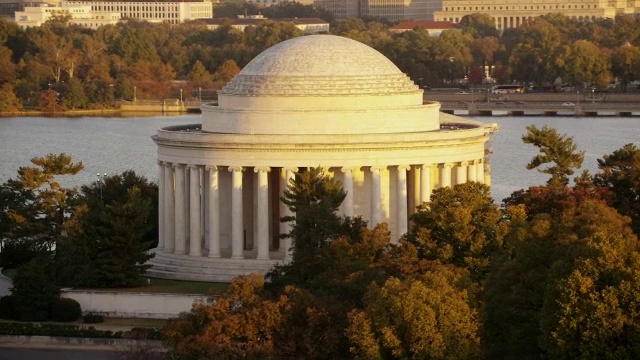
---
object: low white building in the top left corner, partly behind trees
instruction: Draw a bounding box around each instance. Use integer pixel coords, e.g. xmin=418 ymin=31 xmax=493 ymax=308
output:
xmin=15 ymin=4 xmax=120 ymax=29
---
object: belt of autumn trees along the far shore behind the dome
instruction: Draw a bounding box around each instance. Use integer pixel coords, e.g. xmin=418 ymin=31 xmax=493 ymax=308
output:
xmin=0 ymin=9 xmax=640 ymax=112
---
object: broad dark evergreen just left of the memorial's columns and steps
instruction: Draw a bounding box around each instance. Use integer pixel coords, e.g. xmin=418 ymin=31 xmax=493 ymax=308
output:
xmin=55 ymin=171 xmax=158 ymax=287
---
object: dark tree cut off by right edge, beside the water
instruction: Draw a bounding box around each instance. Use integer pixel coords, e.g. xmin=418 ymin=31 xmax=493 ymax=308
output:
xmin=594 ymin=144 xmax=640 ymax=236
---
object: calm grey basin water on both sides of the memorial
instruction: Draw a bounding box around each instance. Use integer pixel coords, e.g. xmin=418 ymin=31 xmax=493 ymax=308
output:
xmin=0 ymin=115 xmax=640 ymax=203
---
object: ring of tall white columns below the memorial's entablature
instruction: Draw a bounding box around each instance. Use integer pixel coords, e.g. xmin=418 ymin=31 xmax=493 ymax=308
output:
xmin=157 ymin=159 xmax=485 ymax=260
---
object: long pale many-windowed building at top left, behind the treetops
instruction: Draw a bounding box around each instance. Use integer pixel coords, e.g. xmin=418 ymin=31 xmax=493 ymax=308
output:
xmin=63 ymin=1 xmax=213 ymax=24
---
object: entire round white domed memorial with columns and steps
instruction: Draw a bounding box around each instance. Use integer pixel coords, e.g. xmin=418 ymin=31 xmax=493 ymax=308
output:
xmin=149 ymin=35 xmax=496 ymax=281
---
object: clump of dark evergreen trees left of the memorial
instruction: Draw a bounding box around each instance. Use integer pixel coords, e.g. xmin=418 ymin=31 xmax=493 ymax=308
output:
xmin=0 ymin=154 xmax=158 ymax=290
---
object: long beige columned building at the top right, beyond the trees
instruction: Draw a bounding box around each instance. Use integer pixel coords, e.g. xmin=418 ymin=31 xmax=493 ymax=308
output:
xmin=435 ymin=0 xmax=640 ymax=30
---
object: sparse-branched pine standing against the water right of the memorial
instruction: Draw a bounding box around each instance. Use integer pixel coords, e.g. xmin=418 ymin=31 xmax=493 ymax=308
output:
xmin=522 ymin=125 xmax=584 ymax=188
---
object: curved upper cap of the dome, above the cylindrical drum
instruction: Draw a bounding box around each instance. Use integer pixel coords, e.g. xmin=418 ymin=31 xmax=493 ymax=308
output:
xmin=219 ymin=35 xmax=421 ymax=96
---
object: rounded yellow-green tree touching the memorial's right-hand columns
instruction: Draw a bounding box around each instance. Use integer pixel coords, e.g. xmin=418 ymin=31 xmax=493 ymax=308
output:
xmin=407 ymin=182 xmax=509 ymax=280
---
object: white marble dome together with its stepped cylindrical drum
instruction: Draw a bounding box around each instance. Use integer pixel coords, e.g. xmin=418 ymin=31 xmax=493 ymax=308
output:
xmin=202 ymin=35 xmax=440 ymax=135
